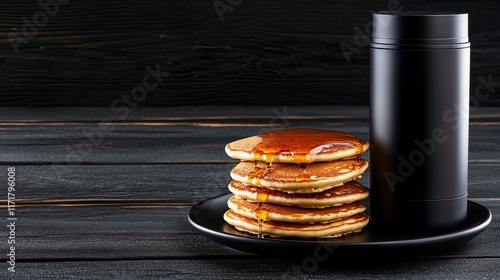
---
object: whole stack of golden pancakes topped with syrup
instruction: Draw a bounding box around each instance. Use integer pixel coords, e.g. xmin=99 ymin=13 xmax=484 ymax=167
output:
xmin=224 ymin=128 xmax=369 ymax=238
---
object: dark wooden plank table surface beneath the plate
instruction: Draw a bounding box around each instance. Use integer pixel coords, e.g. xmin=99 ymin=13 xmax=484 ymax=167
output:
xmin=0 ymin=106 xmax=500 ymax=279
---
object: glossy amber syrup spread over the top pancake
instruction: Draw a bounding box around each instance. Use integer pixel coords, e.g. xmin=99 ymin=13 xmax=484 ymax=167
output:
xmin=252 ymin=128 xmax=366 ymax=164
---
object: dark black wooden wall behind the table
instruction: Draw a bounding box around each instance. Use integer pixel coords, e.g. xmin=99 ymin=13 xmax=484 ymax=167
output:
xmin=0 ymin=0 xmax=500 ymax=107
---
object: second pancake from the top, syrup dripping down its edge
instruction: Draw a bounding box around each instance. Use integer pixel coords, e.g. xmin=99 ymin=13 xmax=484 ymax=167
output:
xmin=230 ymin=159 xmax=368 ymax=193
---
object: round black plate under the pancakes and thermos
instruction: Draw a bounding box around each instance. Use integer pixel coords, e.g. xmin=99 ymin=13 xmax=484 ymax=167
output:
xmin=188 ymin=194 xmax=491 ymax=257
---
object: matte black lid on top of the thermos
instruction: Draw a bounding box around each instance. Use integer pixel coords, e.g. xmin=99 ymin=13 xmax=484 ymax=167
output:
xmin=372 ymin=11 xmax=469 ymax=47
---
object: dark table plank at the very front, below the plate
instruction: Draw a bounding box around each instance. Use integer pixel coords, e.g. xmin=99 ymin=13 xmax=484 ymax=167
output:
xmin=2 ymin=257 xmax=500 ymax=280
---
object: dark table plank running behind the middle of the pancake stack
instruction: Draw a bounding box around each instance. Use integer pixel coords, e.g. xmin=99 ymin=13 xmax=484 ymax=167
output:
xmin=0 ymin=163 xmax=500 ymax=202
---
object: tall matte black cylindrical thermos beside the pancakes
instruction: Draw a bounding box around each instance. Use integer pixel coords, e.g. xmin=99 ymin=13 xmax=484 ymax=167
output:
xmin=370 ymin=12 xmax=470 ymax=233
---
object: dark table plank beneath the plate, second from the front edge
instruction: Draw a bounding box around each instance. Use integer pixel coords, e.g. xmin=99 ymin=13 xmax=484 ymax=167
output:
xmin=0 ymin=200 xmax=500 ymax=261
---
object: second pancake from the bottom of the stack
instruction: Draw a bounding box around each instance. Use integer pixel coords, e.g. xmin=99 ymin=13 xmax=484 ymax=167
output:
xmin=227 ymin=195 xmax=366 ymax=223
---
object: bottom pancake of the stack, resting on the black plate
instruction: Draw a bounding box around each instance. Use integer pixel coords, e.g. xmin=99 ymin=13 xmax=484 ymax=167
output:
xmin=224 ymin=210 xmax=369 ymax=238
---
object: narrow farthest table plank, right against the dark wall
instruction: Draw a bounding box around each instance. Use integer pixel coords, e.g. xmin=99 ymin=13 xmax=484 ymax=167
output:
xmin=0 ymin=103 xmax=500 ymax=123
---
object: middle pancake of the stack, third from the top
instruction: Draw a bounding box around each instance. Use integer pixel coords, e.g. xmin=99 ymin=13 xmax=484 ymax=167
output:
xmin=228 ymin=180 xmax=369 ymax=208
